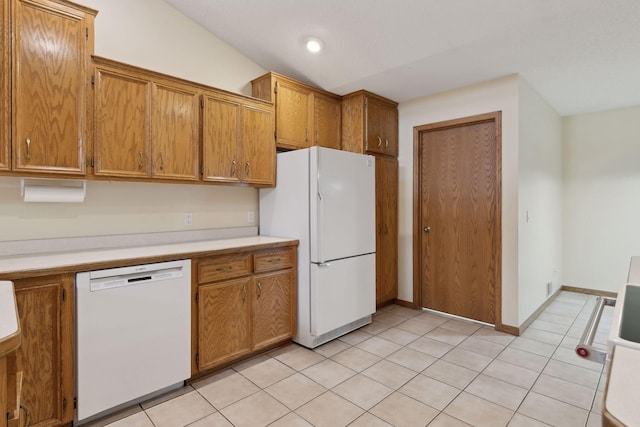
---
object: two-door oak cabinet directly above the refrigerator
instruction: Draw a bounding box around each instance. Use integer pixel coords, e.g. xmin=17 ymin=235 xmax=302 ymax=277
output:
xmin=251 ymin=72 xmax=341 ymax=149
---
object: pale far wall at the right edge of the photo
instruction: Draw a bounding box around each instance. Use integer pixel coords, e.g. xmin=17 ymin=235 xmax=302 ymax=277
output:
xmin=564 ymin=106 xmax=640 ymax=292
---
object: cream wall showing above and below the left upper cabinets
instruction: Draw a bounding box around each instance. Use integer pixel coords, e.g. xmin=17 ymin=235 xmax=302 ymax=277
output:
xmin=0 ymin=0 xmax=265 ymax=241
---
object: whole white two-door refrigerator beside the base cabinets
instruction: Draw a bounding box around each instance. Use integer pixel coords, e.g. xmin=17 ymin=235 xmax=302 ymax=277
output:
xmin=260 ymin=147 xmax=376 ymax=348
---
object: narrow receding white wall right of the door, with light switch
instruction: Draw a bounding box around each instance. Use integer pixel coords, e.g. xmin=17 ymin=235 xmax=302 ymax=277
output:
xmin=516 ymin=78 xmax=563 ymax=325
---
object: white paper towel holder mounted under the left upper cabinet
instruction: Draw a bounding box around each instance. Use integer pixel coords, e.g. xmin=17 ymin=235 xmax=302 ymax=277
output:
xmin=20 ymin=178 xmax=87 ymax=203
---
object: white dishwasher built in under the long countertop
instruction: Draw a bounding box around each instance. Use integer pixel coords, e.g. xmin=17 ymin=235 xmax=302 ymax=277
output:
xmin=76 ymin=260 xmax=191 ymax=424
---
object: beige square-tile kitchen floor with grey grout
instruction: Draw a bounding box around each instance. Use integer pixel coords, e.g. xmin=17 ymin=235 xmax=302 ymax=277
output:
xmin=92 ymin=292 xmax=612 ymax=427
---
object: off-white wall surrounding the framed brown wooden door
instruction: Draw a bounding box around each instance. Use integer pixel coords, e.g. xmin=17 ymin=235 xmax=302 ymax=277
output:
xmin=398 ymin=75 xmax=519 ymax=326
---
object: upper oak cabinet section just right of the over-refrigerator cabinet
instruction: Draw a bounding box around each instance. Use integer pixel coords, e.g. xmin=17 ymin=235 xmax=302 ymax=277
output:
xmin=341 ymin=91 xmax=398 ymax=157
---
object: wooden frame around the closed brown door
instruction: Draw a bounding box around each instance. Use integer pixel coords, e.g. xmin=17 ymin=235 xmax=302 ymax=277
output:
xmin=413 ymin=111 xmax=505 ymax=330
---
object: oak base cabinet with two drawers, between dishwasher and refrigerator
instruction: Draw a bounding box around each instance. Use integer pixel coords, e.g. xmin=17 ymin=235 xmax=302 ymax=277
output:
xmin=192 ymin=246 xmax=297 ymax=375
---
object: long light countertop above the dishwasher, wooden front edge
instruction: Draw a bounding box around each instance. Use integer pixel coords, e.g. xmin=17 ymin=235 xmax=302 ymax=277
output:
xmin=0 ymin=236 xmax=294 ymax=274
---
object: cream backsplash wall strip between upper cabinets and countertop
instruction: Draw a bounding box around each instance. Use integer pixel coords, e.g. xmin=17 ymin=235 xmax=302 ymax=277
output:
xmin=0 ymin=178 xmax=258 ymax=241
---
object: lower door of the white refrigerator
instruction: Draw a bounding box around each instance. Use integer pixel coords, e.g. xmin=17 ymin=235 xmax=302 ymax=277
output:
xmin=311 ymin=254 xmax=376 ymax=336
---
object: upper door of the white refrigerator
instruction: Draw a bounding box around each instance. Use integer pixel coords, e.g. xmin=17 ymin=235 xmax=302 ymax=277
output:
xmin=309 ymin=147 xmax=376 ymax=263
